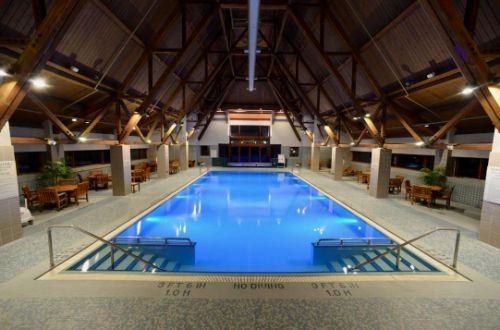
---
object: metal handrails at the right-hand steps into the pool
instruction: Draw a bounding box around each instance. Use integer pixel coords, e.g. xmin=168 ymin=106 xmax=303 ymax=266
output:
xmin=315 ymin=228 xmax=460 ymax=273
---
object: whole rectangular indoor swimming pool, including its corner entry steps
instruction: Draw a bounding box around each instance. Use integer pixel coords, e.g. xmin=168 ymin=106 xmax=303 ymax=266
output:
xmin=68 ymin=171 xmax=437 ymax=274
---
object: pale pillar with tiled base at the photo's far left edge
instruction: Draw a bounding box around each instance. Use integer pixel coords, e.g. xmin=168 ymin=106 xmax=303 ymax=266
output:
xmin=0 ymin=123 xmax=22 ymax=245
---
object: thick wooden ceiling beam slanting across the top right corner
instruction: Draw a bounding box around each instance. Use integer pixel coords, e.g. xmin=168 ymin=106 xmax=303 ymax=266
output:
xmin=420 ymin=0 xmax=500 ymax=129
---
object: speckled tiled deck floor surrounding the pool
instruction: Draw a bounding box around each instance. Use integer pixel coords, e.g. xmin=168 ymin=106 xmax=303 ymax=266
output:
xmin=0 ymin=169 xmax=500 ymax=330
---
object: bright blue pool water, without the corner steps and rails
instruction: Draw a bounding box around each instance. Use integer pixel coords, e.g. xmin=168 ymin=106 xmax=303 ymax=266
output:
xmin=113 ymin=171 xmax=385 ymax=273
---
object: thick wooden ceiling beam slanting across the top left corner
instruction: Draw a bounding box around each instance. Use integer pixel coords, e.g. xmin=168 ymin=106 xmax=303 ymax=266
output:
xmin=0 ymin=0 xmax=82 ymax=130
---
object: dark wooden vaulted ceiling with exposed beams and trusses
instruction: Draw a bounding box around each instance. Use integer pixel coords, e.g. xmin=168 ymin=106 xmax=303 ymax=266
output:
xmin=0 ymin=0 xmax=500 ymax=145
